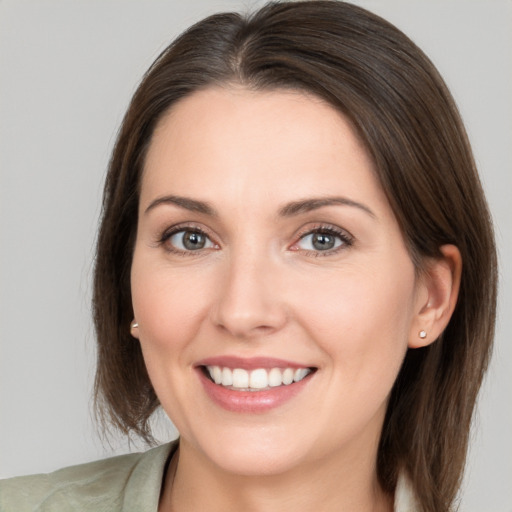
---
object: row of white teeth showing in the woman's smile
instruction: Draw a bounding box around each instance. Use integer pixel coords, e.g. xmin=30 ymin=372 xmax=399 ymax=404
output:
xmin=206 ymin=366 xmax=311 ymax=390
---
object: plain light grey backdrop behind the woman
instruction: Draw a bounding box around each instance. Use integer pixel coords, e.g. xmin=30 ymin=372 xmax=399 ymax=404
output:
xmin=0 ymin=0 xmax=512 ymax=512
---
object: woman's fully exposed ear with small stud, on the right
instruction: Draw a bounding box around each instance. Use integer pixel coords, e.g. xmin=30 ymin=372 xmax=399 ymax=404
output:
xmin=408 ymin=245 xmax=462 ymax=348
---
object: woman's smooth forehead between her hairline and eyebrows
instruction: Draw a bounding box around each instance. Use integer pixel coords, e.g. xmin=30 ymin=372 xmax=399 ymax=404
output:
xmin=141 ymin=87 xmax=387 ymax=216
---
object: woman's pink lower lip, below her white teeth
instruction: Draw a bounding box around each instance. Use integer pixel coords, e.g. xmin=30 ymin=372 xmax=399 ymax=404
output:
xmin=197 ymin=368 xmax=313 ymax=413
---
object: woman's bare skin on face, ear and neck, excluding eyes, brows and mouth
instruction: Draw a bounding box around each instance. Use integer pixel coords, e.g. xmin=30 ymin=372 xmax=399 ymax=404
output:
xmin=131 ymin=87 xmax=460 ymax=512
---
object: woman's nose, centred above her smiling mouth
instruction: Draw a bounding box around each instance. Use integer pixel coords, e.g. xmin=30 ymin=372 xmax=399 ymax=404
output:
xmin=212 ymin=252 xmax=287 ymax=339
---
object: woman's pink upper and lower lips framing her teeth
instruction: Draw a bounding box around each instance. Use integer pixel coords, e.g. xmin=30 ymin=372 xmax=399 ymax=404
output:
xmin=195 ymin=356 xmax=316 ymax=414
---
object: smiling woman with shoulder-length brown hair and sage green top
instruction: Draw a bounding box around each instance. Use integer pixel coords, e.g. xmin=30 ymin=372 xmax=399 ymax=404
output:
xmin=0 ymin=2 xmax=496 ymax=511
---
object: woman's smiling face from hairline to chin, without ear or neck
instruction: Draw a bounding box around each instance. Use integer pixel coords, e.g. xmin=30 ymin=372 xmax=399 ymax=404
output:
xmin=131 ymin=88 xmax=425 ymax=474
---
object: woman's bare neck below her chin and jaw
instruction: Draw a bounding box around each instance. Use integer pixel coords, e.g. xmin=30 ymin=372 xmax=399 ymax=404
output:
xmin=159 ymin=440 xmax=393 ymax=512
